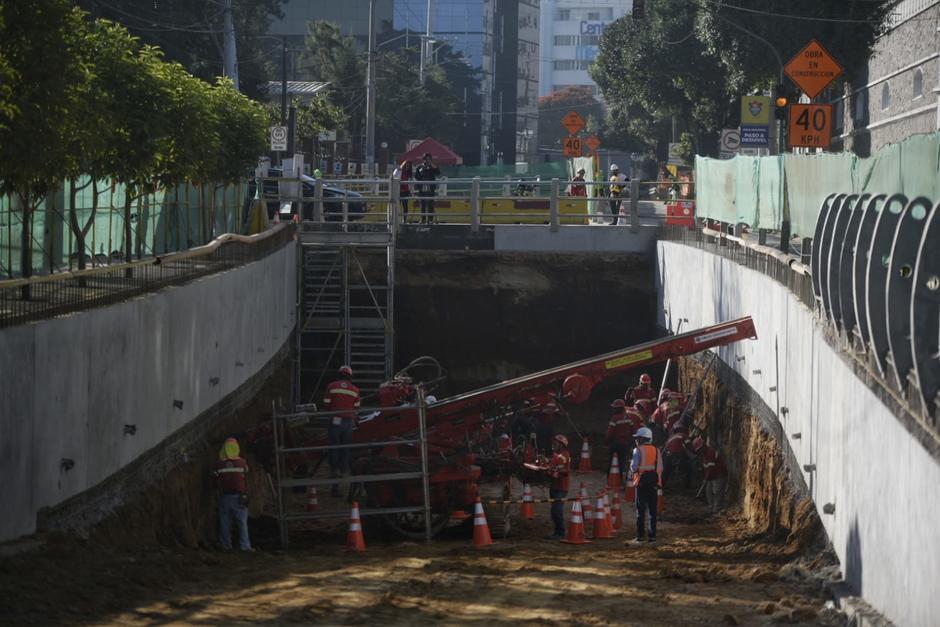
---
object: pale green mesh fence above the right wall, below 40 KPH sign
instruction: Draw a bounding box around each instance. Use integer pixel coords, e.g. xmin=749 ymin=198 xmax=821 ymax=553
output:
xmin=695 ymin=133 xmax=940 ymax=237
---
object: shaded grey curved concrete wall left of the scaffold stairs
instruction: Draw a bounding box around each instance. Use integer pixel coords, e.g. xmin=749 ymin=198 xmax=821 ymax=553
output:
xmin=0 ymin=243 xmax=297 ymax=541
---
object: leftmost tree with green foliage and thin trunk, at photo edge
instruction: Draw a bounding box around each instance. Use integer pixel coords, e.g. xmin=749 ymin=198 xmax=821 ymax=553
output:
xmin=0 ymin=0 xmax=88 ymax=286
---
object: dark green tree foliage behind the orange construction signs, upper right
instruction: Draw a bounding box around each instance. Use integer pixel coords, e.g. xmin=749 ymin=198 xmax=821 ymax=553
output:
xmin=591 ymin=0 xmax=892 ymax=154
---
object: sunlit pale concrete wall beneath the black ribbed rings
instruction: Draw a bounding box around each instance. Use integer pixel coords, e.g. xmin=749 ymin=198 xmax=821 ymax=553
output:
xmin=656 ymin=242 xmax=940 ymax=626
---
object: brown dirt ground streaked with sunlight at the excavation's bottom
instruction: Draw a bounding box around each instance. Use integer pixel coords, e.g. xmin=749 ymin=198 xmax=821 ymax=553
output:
xmin=0 ymin=473 xmax=844 ymax=625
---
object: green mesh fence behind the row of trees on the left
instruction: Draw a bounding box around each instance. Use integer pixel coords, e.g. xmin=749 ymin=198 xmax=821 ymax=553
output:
xmin=0 ymin=179 xmax=247 ymax=278
